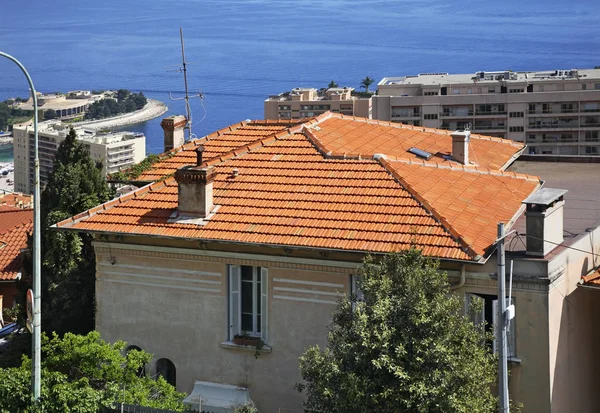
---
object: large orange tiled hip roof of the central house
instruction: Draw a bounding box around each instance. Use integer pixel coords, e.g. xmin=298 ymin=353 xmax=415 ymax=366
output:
xmin=56 ymin=113 xmax=540 ymax=261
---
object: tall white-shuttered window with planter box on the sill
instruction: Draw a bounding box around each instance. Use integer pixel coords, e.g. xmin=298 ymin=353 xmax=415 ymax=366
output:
xmin=229 ymin=265 xmax=268 ymax=342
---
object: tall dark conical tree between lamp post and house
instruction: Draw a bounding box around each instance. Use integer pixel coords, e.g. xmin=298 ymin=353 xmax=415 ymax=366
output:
xmin=27 ymin=129 xmax=113 ymax=334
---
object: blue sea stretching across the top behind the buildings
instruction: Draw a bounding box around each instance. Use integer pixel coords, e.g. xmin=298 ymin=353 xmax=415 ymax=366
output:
xmin=0 ymin=0 xmax=600 ymax=159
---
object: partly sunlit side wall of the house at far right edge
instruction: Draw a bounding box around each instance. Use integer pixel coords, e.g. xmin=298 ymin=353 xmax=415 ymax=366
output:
xmin=548 ymin=228 xmax=600 ymax=413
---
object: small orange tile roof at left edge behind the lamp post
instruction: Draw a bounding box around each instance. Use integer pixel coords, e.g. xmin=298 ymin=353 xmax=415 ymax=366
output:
xmin=0 ymin=209 xmax=33 ymax=280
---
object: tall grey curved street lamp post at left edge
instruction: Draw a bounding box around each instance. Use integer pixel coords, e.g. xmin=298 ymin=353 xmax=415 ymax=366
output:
xmin=0 ymin=51 xmax=42 ymax=402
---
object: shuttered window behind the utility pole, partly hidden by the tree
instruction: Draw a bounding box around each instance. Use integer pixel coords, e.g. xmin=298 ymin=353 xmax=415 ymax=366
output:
xmin=465 ymin=293 xmax=517 ymax=358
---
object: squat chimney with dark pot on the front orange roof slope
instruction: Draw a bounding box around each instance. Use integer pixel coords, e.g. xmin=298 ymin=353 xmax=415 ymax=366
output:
xmin=175 ymin=146 xmax=215 ymax=218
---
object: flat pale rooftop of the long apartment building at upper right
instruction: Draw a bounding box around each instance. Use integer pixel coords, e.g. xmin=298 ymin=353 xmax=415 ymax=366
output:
xmin=378 ymin=69 xmax=600 ymax=86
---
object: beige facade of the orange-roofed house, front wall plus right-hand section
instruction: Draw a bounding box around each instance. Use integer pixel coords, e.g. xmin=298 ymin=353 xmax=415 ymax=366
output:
xmin=88 ymin=216 xmax=600 ymax=413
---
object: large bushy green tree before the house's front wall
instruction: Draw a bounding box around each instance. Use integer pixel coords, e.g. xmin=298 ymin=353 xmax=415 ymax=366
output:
xmin=297 ymin=249 xmax=496 ymax=413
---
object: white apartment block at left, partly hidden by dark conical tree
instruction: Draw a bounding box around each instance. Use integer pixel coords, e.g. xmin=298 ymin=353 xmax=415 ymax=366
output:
xmin=13 ymin=121 xmax=146 ymax=193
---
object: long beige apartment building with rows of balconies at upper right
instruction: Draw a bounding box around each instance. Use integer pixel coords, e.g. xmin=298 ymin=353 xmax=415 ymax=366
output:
xmin=373 ymin=69 xmax=600 ymax=155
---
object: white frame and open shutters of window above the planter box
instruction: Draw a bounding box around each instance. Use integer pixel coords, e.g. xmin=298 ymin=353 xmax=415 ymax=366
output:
xmin=228 ymin=265 xmax=269 ymax=343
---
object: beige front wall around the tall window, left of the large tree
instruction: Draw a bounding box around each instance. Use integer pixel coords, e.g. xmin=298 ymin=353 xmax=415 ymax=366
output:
xmin=96 ymin=243 xmax=351 ymax=412
